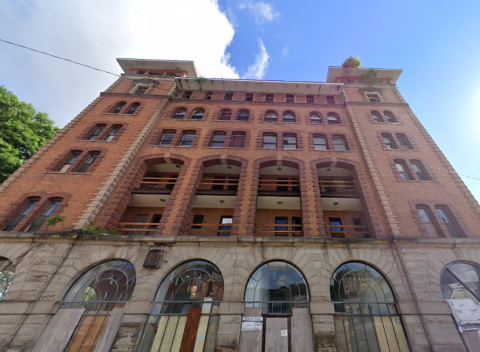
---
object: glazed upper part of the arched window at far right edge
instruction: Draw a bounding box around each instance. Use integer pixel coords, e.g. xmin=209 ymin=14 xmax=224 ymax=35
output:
xmin=440 ymin=262 xmax=480 ymax=302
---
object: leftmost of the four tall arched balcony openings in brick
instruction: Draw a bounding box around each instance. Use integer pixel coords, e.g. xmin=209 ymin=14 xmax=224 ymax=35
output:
xmin=118 ymin=157 xmax=188 ymax=236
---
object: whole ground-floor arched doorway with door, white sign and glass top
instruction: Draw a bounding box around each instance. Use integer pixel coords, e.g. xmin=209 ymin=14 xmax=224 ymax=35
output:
xmin=240 ymin=261 xmax=313 ymax=352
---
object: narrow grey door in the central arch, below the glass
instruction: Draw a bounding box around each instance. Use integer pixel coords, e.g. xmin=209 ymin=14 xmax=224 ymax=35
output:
xmin=263 ymin=317 xmax=291 ymax=352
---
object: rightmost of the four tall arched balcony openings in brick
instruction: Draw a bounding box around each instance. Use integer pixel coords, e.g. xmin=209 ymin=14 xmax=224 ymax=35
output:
xmin=316 ymin=160 xmax=375 ymax=238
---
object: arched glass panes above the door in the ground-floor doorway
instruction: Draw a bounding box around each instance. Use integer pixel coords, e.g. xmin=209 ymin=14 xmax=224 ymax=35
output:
xmin=245 ymin=261 xmax=310 ymax=314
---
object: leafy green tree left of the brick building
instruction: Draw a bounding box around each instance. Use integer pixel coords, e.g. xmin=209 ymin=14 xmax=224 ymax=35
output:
xmin=0 ymin=86 xmax=60 ymax=183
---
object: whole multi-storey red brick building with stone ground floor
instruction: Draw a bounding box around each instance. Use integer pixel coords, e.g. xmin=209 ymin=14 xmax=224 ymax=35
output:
xmin=0 ymin=59 xmax=480 ymax=352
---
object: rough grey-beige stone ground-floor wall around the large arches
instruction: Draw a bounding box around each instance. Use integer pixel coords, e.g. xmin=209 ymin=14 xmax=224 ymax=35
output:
xmin=0 ymin=233 xmax=474 ymax=352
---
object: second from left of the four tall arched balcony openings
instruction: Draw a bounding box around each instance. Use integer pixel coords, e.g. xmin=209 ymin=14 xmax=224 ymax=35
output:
xmin=185 ymin=157 xmax=246 ymax=236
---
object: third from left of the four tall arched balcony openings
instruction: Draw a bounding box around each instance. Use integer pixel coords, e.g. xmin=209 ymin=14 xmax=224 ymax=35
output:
xmin=255 ymin=160 xmax=303 ymax=237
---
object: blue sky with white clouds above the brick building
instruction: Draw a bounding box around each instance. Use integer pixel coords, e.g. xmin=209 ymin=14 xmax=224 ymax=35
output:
xmin=0 ymin=0 xmax=480 ymax=199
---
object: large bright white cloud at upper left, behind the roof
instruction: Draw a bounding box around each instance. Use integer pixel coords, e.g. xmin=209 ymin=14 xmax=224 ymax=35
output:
xmin=0 ymin=0 xmax=238 ymax=126
